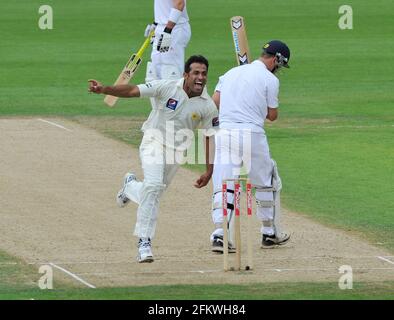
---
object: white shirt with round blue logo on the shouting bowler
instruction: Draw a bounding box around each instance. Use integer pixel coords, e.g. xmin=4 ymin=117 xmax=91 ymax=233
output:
xmin=138 ymin=78 xmax=218 ymax=150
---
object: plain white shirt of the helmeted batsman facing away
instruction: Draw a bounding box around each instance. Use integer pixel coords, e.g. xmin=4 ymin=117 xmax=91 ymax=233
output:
xmin=215 ymin=60 xmax=279 ymax=132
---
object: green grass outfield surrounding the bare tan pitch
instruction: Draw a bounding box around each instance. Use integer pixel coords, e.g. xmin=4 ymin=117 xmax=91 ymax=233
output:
xmin=0 ymin=0 xmax=394 ymax=299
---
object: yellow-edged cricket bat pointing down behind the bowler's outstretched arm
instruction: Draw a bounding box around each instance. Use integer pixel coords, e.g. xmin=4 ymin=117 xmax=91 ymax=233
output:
xmin=104 ymin=30 xmax=155 ymax=107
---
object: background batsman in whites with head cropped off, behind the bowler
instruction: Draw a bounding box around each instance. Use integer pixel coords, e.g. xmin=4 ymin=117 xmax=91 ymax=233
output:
xmin=145 ymin=0 xmax=191 ymax=81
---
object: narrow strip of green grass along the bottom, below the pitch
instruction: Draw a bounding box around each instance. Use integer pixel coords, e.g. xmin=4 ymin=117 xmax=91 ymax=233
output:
xmin=4 ymin=282 xmax=394 ymax=300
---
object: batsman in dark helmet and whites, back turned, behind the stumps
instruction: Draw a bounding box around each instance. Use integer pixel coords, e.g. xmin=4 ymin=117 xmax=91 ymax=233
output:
xmin=211 ymin=40 xmax=290 ymax=252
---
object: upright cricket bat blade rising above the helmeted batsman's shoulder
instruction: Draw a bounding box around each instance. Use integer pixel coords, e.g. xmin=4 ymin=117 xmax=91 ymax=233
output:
xmin=230 ymin=16 xmax=252 ymax=65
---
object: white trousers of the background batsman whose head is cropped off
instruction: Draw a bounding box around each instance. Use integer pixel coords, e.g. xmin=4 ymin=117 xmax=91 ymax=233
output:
xmin=151 ymin=23 xmax=191 ymax=79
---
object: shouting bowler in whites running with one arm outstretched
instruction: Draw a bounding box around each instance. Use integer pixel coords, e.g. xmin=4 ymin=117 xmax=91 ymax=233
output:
xmin=89 ymin=56 xmax=218 ymax=262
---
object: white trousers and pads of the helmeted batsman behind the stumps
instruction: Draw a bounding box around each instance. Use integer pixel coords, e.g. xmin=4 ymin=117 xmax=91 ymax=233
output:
xmin=212 ymin=129 xmax=274 ymax=234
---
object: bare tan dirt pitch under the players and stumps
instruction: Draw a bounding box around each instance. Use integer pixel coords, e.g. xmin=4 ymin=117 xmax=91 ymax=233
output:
xmin=0 ymin=118 xmax=394 ymax=287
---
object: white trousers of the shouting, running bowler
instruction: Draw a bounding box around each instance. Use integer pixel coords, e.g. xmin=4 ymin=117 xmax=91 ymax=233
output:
xmin=125 ymin=136 xmax=179 ymax=239
